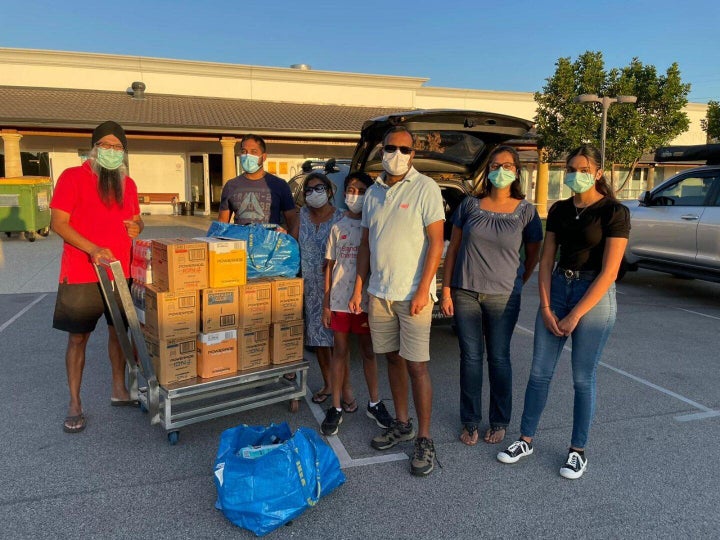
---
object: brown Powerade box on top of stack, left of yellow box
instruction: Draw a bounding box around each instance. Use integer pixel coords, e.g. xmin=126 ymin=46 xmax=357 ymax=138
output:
xmin=152 ymin=238 xmax=208 ymax=292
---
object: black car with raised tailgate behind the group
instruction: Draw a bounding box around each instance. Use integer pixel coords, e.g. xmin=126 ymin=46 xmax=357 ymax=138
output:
xmin=350 ymin=110 xmax=532 ymax=322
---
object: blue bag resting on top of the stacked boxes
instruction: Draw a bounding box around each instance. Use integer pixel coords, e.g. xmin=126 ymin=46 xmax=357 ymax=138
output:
xmin=206 ymin=221 xmax=300 ymax=279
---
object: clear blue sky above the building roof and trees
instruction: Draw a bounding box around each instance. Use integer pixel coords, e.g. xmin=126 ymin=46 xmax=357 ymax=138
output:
xmin=0 ymin=0 xmax=720 ymax=103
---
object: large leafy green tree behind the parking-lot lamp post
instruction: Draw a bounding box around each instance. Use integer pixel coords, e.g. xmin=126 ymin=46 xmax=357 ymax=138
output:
xmin=535 ymin=51 xmax=690 ymax=186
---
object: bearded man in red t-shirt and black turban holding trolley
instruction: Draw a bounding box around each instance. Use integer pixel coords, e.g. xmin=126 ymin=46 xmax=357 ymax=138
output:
xmin=50 ymin=121 xmax=144 ymax=433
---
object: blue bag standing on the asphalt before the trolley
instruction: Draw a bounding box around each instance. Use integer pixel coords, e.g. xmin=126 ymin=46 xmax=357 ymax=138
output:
xmin=214 ymin=422 xmax=345 ymax=536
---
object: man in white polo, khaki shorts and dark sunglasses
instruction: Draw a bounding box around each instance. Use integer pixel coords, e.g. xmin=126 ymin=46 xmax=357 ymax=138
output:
xmin=349 ymin=126 xmax=445 ymax=476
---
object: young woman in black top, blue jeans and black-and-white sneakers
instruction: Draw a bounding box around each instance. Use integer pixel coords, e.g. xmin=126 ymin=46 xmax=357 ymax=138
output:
xmin=497 ymin=145 xmax=630 ymax=479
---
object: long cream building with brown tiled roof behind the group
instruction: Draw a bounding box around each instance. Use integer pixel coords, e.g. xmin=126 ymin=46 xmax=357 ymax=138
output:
xmin=0 ymin=48 xmax=706 ymax=214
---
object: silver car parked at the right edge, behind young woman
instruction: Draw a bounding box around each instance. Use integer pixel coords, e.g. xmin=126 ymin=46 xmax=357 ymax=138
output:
xmin=618 ymin=145 xmax=720 ymax=282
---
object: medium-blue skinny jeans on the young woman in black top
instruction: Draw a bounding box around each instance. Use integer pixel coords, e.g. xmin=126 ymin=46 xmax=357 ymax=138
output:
xmin=520 ymin=272 xmax=617 ymax=449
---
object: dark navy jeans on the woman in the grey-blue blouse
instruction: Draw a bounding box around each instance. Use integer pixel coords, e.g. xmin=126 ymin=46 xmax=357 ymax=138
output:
xmin=452 ymin=289 xmax=520 ymax=427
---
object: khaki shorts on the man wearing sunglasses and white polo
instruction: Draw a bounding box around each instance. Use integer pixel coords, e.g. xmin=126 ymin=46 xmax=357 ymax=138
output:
xmin=368 ymin=294 xmax=433 ymax=362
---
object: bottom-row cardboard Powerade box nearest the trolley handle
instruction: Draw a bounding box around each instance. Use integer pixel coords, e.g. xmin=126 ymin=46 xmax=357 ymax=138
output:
xmin=145 ymin=336 xmax=197 ymax=386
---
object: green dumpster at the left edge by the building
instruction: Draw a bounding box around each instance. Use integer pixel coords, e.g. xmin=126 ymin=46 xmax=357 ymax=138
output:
xmin=0 ymin=176 xmax=52 ymax=242
